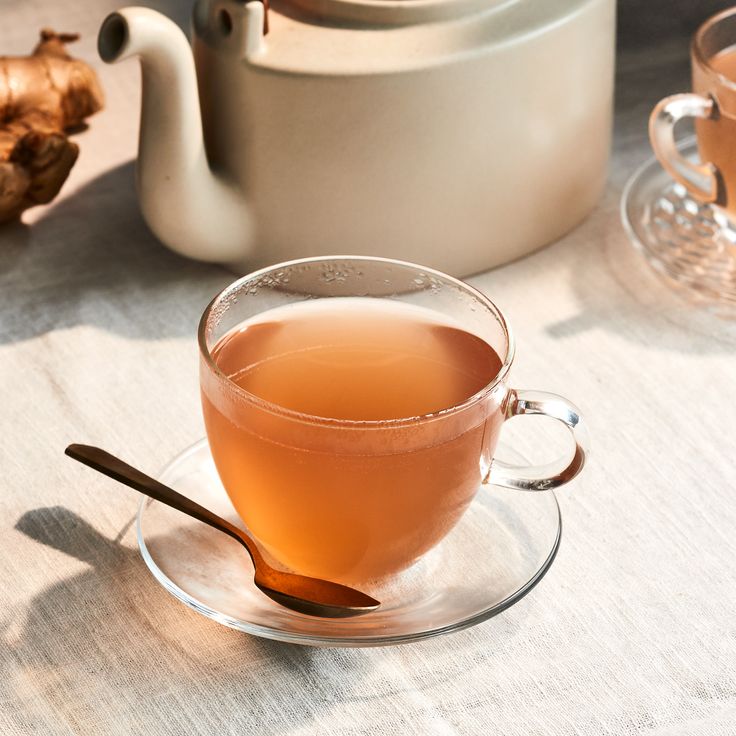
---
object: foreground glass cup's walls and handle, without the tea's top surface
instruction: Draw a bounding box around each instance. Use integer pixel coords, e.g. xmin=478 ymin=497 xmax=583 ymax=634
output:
xmin=199 ymin=256 xmax=586 ymax=583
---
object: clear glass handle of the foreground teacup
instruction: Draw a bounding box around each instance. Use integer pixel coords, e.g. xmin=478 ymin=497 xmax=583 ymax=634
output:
xmin=486 ymin=391 xmax=588 ymax=491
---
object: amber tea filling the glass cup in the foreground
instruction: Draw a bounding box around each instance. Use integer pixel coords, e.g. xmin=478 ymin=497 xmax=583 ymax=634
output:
xmin=202 ymin=297 xmax=502 ymax=582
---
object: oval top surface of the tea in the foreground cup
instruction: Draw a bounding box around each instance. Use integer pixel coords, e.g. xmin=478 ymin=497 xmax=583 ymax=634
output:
xmin=213 ymin=299 xmax=501 ymax=421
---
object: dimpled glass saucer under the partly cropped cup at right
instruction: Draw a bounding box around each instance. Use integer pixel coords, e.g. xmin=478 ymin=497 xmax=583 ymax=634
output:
xmin=621 ymin=137 xmax=736 ymax=317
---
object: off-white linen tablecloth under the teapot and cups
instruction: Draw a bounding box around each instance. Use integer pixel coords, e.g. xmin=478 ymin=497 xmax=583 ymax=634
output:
xmin=0 ymin=0 xmax=736 ymax=736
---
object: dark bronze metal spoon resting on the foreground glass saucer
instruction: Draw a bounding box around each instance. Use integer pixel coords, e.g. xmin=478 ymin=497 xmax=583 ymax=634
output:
xmin=65 ymin=445 xmax=381 ymax=618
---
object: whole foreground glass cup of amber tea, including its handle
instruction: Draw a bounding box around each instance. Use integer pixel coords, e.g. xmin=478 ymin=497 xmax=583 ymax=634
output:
xmin=199 ymin=257 xmax=585 ymax=583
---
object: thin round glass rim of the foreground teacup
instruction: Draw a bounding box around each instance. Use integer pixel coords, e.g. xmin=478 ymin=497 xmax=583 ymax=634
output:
xmin=197 ymin=255 xmax=516 ymax=429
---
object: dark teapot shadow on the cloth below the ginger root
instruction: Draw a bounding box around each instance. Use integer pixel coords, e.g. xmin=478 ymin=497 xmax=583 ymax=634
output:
xmin=0 ymin=162 xmax=233 ymax=343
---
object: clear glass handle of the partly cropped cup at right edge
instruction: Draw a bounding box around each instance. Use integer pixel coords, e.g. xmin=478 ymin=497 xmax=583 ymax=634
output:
xmin=649 ymin=92 xmax=722 ymax=203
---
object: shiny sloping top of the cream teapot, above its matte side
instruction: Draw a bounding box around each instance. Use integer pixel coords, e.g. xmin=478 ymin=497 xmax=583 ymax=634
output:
xmin=194 ymin=0 xmax=604 ymax=76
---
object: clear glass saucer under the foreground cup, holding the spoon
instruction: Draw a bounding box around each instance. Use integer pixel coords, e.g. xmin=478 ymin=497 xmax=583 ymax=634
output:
xmin=137 ymin=440 xmax=561 ymax=647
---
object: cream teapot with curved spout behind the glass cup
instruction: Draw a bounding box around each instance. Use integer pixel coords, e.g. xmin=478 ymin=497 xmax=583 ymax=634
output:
xmin=98 ymin=0 xmax=615 ymax=275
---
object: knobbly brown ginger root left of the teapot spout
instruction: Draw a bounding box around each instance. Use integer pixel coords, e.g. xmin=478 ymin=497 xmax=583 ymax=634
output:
xmin=0 ymin=29 xmax=104 ymax=223
